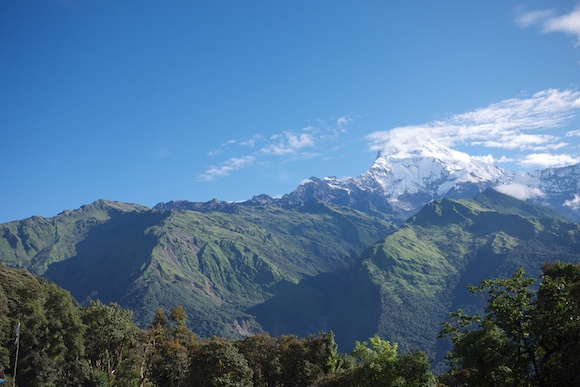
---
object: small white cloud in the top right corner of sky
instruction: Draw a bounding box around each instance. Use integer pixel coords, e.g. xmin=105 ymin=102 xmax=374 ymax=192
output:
xmin=516 ymin=7 xmax=580 ymax=42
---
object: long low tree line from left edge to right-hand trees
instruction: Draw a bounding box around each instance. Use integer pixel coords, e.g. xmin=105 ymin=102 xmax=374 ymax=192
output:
xmin=0 ymin=264 xmax=433 ymax=386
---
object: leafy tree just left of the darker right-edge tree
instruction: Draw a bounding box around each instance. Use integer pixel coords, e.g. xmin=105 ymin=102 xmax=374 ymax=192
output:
xmin=440 ymin=269 xmax=538 ymax=386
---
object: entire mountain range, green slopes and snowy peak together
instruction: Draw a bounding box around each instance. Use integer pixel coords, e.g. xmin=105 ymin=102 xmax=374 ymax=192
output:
xmin=0 ymin=140 xmax=580 ymax=363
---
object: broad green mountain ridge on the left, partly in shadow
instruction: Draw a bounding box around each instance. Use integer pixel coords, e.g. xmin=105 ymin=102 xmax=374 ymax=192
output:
xmin=0 ymin=200 xmax=392 ymax=336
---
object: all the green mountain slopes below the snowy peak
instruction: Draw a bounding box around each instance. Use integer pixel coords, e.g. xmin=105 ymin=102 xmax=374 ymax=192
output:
xmin=0 ymin=191 xmax=580 ymax=360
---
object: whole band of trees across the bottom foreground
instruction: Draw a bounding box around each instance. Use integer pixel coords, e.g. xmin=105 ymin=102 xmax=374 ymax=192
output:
xmin=0 ymin=262 xmax=580 ymax=387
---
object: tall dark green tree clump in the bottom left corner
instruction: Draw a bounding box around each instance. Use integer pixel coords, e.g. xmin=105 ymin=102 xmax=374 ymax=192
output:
xmin=0 ymin=264 xmax=87 ymax=386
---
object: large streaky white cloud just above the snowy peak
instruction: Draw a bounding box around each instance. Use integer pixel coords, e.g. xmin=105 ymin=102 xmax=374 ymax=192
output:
xmin=367 ymin=89 xmax=580 ymax=165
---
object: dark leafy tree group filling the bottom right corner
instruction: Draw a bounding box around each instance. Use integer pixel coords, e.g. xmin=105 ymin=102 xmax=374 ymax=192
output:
xmin=441 ymin=263 xmax=580 ymax=386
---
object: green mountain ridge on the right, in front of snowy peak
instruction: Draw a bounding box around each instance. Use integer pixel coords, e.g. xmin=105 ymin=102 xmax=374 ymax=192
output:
xmin=333 ymin=190 xmax=580 ymax=370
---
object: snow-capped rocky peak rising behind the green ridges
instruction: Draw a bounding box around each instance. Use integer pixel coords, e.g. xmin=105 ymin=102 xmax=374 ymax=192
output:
xmin=281 ymin=139 xmax=580 ymax=220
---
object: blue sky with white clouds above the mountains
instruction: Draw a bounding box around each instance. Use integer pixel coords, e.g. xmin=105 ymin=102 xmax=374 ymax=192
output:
xmin=0 ymin=0 xmax=580 ymax=222
